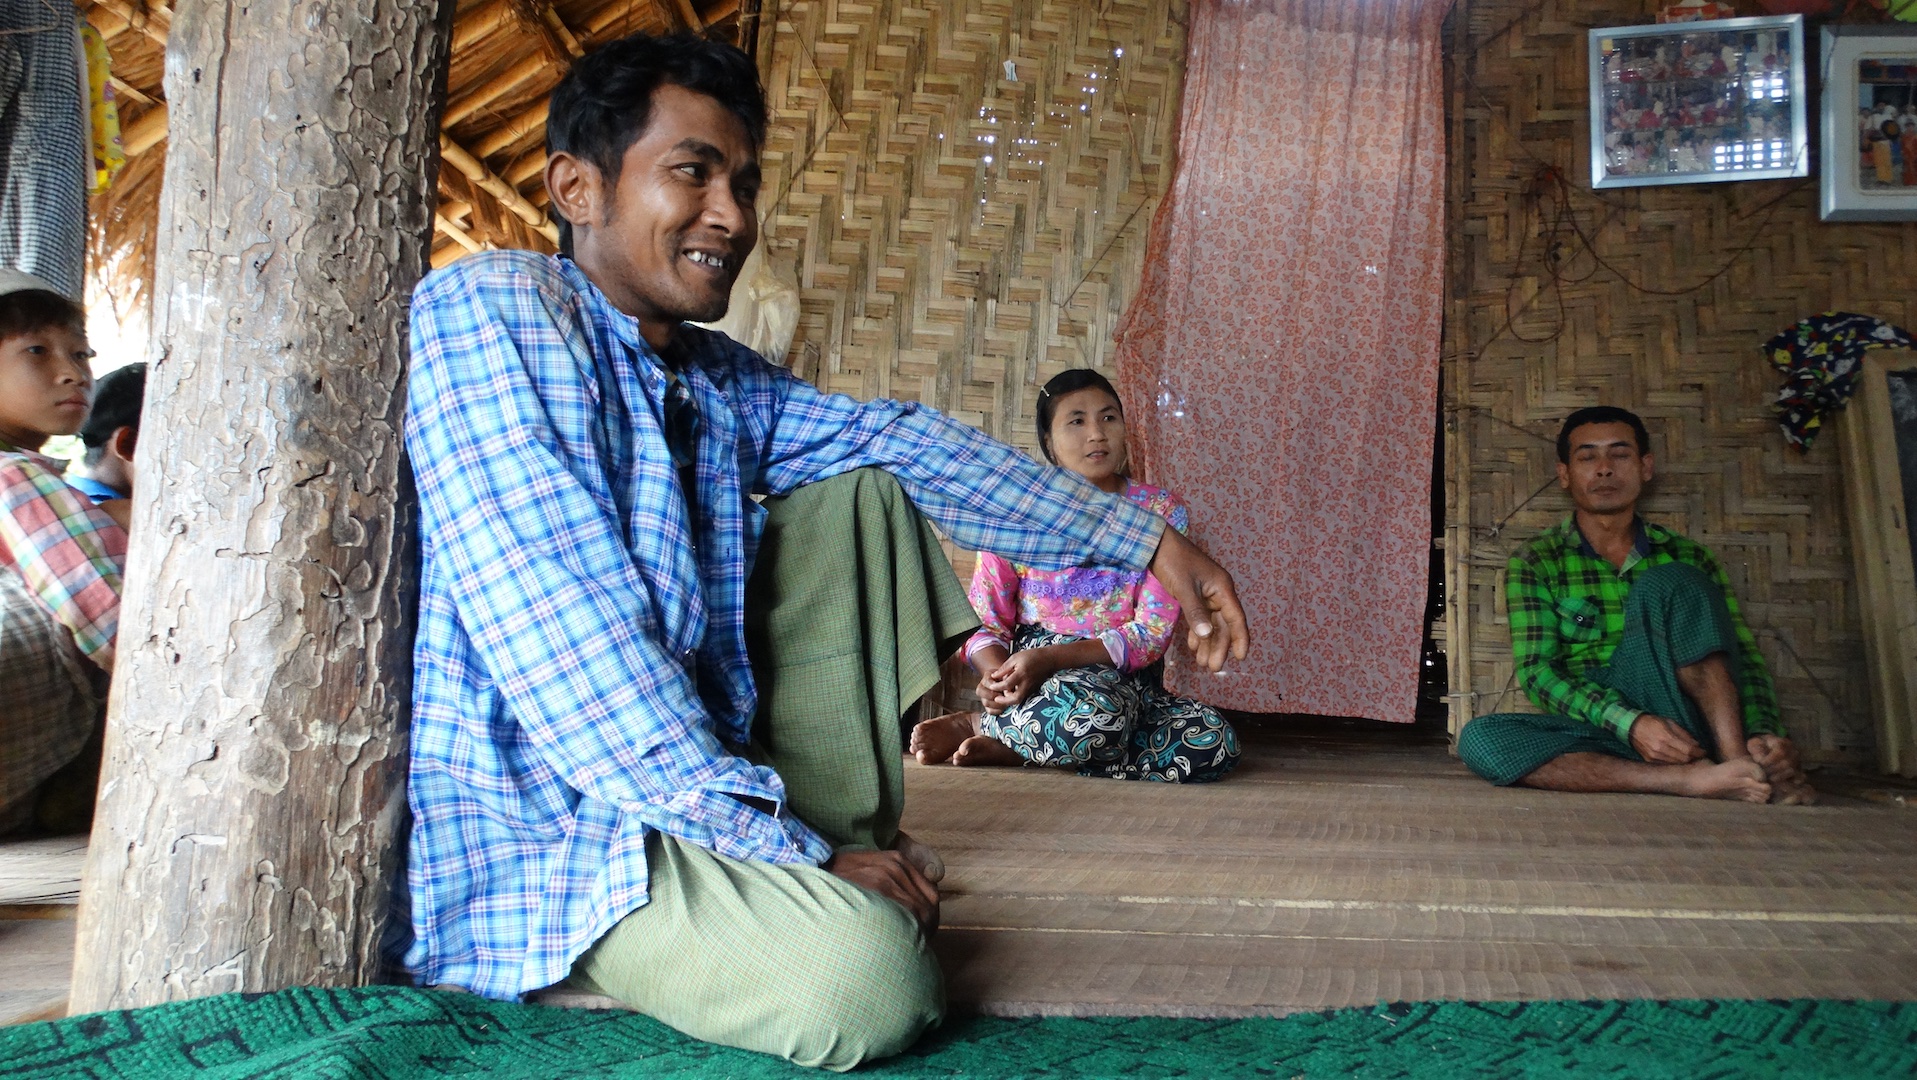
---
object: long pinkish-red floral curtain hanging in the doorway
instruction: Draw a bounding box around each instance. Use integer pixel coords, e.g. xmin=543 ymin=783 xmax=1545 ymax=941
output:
xmin=1118 ymin=0 xmax=1449 ymax=721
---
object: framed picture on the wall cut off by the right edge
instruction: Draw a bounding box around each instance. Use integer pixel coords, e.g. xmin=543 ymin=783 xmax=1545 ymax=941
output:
xmin=1819 ymin=27 xmax=1917 ymax=221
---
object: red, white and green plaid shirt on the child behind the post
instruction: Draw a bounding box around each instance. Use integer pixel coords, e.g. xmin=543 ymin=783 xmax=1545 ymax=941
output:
xmin=0 ymin=443 xmax=127 ymax=666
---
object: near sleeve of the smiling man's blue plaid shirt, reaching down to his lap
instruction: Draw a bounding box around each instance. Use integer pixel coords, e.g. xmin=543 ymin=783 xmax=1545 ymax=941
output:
xmin=408 ymin=276 xmax=830 ymax=863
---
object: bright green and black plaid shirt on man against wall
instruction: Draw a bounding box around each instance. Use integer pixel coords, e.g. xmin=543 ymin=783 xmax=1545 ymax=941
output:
xmin=1507 ymin=516 xmax=1785 ymax=740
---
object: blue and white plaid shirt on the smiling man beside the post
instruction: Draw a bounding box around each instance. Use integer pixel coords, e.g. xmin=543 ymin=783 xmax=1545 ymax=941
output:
xmin=395 ymin=251 xmax=1164 ymax=998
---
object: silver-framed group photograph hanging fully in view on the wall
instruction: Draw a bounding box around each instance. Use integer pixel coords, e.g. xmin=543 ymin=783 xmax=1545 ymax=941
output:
xmin=1591 ymin=15 xmax=1810 ymax=188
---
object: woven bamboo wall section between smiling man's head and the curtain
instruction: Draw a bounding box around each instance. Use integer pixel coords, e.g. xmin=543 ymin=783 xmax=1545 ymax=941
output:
xmin=759 ymin=0 xmax=1185 ymax=462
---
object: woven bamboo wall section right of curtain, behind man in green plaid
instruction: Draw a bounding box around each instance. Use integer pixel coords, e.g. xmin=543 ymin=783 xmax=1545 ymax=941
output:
xmin=1445 ymin=0 xmax=1917 ymax=762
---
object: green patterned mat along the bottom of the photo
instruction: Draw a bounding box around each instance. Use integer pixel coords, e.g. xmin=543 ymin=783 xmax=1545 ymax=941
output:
xmin=0 ymin=988 xmax=1917 ymax=1080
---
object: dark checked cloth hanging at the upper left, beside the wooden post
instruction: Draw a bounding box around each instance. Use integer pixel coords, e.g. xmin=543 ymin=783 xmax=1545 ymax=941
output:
xmin=0 ymin=0 xmax=94 ymax=299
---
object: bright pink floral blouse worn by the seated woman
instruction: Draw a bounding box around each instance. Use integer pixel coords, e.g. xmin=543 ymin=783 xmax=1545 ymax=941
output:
xmin=964 ymin=480 xmax=1190 ymax=671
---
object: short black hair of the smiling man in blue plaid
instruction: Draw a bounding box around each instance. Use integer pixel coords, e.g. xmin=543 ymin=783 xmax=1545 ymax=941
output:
xmin=546 ymin=33 xmax=765 ymax=253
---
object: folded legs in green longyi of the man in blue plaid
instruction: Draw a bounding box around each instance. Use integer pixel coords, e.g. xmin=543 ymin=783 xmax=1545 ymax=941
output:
xmin=573 ymin=468 xmax=978 ymax=1070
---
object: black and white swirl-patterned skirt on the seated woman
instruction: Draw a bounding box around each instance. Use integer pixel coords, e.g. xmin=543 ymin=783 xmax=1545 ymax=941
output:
xmin=980 ymin=625 xmax=1238 ymax=785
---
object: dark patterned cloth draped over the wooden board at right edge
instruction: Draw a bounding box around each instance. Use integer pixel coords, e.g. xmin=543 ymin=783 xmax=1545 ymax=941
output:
xmin=1764 ymin=311 xmax=1917 ymax=451
